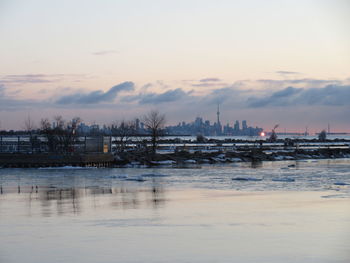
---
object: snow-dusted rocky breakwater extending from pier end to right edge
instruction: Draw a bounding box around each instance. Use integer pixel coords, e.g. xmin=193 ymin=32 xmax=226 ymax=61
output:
xmin=115 ymin=145 xmax=350 ymax=166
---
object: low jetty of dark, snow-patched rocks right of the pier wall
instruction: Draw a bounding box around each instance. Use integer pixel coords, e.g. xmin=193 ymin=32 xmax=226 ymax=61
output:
xmin=115 ymin=148 xmax=350 ymax=167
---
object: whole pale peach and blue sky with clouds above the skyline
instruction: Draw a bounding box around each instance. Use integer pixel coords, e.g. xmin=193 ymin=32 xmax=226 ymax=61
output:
xmin=0 ymin=0 xmax=350 ymax=132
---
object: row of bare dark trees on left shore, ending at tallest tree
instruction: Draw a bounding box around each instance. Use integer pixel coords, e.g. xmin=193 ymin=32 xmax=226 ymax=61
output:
xmin=10 ymin=110 xmax=166 ymax=154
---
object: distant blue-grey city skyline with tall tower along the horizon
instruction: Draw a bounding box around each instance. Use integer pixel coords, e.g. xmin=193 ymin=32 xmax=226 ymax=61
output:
xmin=0 ymin=110 xmax=342 ymax=136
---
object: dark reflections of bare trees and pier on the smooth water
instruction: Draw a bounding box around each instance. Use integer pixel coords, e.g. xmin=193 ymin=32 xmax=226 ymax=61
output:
xmin=0 ymin=183 xmax=166 ymax=217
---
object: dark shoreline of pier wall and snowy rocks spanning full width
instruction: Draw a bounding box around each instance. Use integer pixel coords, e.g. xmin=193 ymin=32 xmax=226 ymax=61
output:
xmin=0 ymin=141 xmax=350 ymax=168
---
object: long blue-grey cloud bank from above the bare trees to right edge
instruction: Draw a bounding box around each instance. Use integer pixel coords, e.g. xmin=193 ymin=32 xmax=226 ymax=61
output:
xmin=121 ymin=81 xmax=350 ymax=109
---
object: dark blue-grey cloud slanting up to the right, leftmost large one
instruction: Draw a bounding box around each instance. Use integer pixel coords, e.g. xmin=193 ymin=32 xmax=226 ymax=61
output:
xmin=56 ymin=81 xmax=134 ymax=104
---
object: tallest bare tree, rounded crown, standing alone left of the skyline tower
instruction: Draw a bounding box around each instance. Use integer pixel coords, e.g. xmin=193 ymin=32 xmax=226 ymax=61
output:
xmin=143 ymin=110 xmax=165 ymax=154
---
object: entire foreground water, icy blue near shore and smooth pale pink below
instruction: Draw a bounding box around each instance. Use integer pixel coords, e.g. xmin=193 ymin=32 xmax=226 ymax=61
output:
xmin=0 ymin=159 xmax=350 ymax=263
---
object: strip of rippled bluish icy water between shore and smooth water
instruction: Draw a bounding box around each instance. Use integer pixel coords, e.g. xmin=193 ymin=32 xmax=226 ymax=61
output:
xmin=0 ymin=159 xmax=350 ymax=195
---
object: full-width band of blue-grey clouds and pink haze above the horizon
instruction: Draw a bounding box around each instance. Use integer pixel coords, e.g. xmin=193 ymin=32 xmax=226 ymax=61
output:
xmin=0 ymin=74 xmax=350 ymax=131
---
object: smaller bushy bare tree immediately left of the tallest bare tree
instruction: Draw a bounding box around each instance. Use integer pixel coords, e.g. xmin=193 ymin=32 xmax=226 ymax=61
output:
xmin=112 ymin=120 xmax=136 ymax=152
